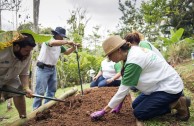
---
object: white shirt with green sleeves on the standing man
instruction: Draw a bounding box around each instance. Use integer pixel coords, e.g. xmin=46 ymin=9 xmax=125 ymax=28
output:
xmin=38 ymin=39 xmax=66 ymax=65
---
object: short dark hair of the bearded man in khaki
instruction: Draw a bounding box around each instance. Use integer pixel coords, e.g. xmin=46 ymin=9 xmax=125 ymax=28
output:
xmin=13 ymin=33 xmax=36 ymax=48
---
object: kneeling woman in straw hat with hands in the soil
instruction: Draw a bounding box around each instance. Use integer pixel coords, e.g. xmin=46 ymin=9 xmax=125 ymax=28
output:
xmin=90 ymin=36 xmax=190 ymax=121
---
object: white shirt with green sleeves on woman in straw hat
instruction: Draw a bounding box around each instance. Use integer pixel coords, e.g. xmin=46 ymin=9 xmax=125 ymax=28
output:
xmin=108 ymin=46 xmax=184 ymax=108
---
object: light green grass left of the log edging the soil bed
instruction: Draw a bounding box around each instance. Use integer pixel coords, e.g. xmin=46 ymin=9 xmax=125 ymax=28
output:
xmin=0 ymin=84 xmax=89 ymax=126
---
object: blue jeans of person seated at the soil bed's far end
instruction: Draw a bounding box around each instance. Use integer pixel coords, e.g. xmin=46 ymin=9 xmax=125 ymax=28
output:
xmin=90 ymin=76 xmax=121 ymax=87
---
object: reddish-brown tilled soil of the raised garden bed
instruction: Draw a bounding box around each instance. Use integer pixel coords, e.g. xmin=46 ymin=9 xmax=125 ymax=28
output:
xmin=25 ymin=87 xmax=136 ymax=126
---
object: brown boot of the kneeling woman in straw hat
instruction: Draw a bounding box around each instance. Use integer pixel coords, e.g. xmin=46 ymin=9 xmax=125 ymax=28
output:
xmin=170 ymin=96 xmax=191 ymax=121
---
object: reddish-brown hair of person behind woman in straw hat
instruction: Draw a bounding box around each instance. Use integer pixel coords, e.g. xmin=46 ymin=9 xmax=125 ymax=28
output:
xmin=124 ymin=31 xmax=144 ymax=44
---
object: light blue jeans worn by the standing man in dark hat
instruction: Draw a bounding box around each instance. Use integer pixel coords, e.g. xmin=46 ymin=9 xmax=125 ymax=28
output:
xmin=33 ymin=66 xmax=57 ymax=110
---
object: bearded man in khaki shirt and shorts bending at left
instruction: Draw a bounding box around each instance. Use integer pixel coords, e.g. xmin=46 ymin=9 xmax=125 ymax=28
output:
xmin=0 ymin=33 xmax=36 ymax=118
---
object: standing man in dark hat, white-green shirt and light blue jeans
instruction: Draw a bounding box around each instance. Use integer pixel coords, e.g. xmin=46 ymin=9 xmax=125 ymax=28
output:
xmin=33 ymin=27 xmax=79 ymax=110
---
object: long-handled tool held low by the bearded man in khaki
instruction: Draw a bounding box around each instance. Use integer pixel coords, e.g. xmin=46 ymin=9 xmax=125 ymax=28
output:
xmin=0 ymin=86 xmax=65 ymax=102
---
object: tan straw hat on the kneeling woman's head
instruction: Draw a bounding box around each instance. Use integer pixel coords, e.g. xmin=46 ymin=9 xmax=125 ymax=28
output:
xmin=102 ymin=36 xmax=126 ymax=56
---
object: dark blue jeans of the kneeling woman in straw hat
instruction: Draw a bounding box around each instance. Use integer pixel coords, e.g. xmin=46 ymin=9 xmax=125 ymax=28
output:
xmin=132 ymin=91 xmax=182 ymax=120
